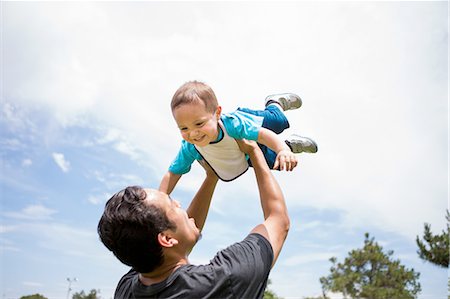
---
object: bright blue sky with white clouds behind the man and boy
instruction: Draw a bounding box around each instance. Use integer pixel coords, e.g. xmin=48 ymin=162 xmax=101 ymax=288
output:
xmin=0 ymin=1 xmax=449 ymax=299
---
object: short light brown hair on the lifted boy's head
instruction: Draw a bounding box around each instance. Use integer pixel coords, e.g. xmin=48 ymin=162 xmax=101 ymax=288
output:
xmin=170 ymin=81 xmax=219 ymax=113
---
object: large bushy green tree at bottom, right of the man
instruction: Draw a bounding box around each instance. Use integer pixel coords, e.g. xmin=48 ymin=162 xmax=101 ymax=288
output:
xmin=320 ymin=233 xmax=421 ymax=299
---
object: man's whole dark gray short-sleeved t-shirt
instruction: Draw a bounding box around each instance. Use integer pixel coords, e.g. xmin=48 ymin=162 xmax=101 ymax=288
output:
xmin=114 ymin=234 xmax=273 ymax=299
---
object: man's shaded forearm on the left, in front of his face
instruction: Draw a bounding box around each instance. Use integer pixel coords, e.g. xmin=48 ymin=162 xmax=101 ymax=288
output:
xmin=187 ymin=162 xmax=218 ymax=231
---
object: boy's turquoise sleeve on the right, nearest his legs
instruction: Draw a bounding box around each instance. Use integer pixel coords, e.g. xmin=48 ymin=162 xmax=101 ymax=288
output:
xmin=221 ymin=110 xmax=264 ymax=141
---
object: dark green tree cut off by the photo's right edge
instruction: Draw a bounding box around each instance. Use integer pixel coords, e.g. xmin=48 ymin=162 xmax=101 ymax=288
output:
xmin=416 ymin=210 xmax=450 ymax=268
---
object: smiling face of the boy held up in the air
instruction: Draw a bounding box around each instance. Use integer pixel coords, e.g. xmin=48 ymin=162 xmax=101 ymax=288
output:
xmin=172 ymin=101 xmax=221 ymax=147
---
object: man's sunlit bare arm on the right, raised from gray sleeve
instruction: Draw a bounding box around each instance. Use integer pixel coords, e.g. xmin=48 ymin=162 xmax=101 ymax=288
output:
xmin=238 ymin=140 xmax=290 ymax=266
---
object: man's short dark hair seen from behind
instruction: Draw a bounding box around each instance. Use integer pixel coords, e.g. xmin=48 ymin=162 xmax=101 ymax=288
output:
xmin=97 ymin=186 xmax=176 ymax=273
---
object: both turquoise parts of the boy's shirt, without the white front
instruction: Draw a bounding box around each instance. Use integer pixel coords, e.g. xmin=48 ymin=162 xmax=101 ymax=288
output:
xmin=169 ymin=110 xmax=264 ymax=174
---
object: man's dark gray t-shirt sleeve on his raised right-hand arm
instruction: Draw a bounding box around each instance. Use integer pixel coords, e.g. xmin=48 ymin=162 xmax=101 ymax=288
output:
xmin=211 ymin=234 xmax=273 ymax=298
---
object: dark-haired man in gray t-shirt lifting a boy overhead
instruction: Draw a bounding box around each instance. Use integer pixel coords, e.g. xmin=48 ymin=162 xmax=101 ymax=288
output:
xmin=98 ymin=140 xmax=289 ymax=298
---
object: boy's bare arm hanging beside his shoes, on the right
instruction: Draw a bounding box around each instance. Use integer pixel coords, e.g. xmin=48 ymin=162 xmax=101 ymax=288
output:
xmin=258 ymin=128 xmax=298 ymax=171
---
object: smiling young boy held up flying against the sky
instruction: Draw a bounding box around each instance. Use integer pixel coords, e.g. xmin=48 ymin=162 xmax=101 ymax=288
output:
xmin=159 ymin=81 xmax=317 ymax=194
